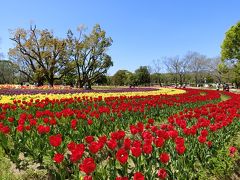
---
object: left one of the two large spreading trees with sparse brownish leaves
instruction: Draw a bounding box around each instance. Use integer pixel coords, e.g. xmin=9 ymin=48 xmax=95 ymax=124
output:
xmin=9 ymin=26 xmax=72 ymax=86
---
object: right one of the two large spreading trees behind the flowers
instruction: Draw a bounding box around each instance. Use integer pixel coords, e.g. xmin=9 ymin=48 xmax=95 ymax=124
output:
xmin=67 ymin=24 xmax=113 ymax=88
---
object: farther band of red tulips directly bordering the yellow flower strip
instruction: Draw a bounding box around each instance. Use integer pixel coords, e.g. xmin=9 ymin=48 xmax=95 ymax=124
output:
xmin=0 ymin=90 xmax=219 ymax=138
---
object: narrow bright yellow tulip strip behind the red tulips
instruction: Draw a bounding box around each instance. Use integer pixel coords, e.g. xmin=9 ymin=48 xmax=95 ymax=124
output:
xmin=0 ymin=88 xmax=185 ymax=103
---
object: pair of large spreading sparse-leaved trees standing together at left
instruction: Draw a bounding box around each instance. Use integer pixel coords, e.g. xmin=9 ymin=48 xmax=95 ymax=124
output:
xmin=9 ymin=24 xmax=113 ymax=87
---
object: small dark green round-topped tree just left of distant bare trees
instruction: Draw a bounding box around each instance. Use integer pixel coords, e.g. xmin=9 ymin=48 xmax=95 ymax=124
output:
xmin=135 ymin=66 xmax=150 ymax=85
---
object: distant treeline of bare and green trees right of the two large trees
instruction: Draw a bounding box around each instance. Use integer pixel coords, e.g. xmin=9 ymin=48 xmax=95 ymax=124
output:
xmin=109 ymin=52 xmax=234 ymax=86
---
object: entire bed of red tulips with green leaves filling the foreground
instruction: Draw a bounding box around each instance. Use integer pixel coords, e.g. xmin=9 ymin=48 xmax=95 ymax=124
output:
xmin=0 ymin=89 xmax=240 ymax=180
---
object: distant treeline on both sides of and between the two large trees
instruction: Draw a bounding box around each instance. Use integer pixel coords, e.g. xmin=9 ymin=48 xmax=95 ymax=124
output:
xmin=0 ymin=52 xmax=234 ymax=86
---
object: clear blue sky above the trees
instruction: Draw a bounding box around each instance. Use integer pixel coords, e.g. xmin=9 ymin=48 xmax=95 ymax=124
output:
xmin=0 ymin=0 xmax=240 ymax=75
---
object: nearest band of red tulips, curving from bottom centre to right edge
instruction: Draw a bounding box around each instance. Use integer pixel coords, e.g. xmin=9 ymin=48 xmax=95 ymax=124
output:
xmin=46 ymin=90 xmax=237 ymax=179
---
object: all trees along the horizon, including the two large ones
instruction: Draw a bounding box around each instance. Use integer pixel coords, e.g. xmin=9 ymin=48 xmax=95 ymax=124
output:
xmin=0 ymin=22 xmax=240 ymax=89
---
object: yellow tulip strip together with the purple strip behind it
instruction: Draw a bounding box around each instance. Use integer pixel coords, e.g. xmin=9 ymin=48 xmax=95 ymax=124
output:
xmin=0 ymin=88 xmax=185 ymax=103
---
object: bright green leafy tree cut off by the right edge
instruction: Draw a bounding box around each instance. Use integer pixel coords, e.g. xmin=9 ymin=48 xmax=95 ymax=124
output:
xmin=221 ymin=21 xmax=240 ymax=88
